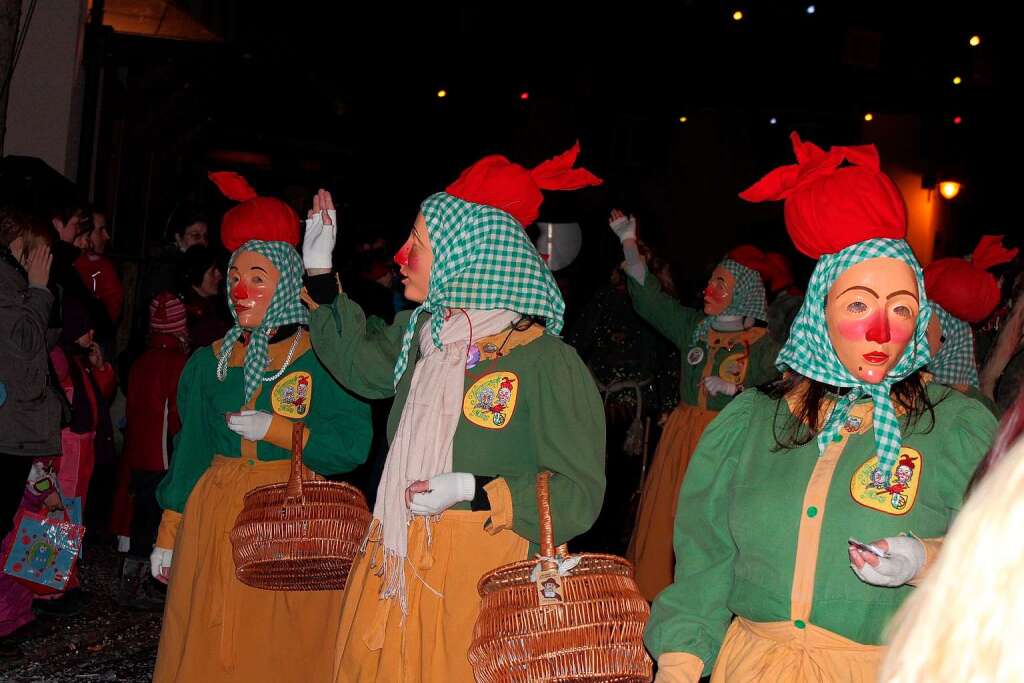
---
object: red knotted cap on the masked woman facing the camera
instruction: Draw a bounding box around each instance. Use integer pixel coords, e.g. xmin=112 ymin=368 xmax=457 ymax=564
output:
xmin=739 ymin=133 xmax=906 ymax=259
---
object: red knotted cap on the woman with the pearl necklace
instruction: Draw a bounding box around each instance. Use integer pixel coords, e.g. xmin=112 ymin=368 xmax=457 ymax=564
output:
xmin=210 ymin=171 xmax=299 ymax=251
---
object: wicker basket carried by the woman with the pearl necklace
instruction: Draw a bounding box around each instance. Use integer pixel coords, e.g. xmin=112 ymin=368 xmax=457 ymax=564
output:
xmin=231 ymin=422 xmax=371 ymax=591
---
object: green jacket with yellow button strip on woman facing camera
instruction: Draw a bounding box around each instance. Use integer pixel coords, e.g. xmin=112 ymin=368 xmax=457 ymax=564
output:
xmin=645 ymin=383 xmax=995 ymax=673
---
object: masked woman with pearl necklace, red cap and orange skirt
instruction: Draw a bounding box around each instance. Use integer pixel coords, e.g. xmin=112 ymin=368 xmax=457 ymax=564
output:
xmin=149 ymin=173 xmax=371 ymax=683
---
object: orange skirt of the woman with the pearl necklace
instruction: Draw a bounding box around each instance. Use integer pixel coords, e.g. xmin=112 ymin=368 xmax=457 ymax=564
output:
xmin=153 ymin=456 xmax=343 ymax=683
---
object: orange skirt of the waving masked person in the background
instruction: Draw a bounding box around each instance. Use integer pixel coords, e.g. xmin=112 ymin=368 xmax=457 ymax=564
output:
xmin=626 ymin=403 xmax=718 ymax=601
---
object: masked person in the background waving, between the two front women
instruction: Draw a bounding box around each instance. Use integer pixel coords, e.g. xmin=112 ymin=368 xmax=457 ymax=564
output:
xmin=609 ymin=209 xmax=779 ymax=600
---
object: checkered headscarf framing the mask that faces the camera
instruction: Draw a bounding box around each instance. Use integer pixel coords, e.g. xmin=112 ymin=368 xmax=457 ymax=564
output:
xmin=775 ymin=239 xmax=932 ymax=476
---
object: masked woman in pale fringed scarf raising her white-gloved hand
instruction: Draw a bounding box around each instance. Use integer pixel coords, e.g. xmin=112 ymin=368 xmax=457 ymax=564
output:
xmin=303 ymin=141 xmax=604 ymax=683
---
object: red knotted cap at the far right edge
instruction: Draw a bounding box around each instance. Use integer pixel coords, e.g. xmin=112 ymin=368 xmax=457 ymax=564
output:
xmin=925 ymin=234 xmax=1018 ymax=324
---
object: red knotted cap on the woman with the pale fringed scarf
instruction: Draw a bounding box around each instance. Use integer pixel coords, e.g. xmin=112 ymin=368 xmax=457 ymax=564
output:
xmin=444 ymin=142 xmax=603 ymax=227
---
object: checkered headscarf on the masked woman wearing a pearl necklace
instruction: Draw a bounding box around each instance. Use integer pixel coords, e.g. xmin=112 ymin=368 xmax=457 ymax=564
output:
xmin=219 ymin=240 xmax=309 ymax=403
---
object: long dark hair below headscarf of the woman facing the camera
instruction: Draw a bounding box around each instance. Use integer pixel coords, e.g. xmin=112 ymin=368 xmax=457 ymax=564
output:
xmin=759 ymin=372 xmax=942 ymax=451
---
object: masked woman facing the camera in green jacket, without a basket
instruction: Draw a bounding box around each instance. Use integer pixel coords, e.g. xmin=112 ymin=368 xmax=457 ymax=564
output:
xmin=645 ymin=134 xmax=995 ymax=683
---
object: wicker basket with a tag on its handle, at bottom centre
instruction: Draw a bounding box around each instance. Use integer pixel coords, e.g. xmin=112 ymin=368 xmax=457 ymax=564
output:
xmin=469 ymin=472 xmax=652 ymax=683
